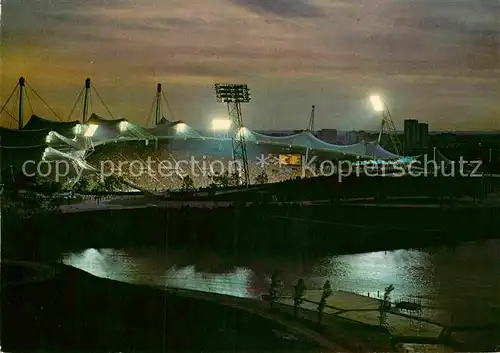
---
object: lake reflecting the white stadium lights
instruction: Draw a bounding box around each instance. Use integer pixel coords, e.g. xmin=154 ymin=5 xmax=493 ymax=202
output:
xmin=62 ymin=241 xmax=500 ymax=322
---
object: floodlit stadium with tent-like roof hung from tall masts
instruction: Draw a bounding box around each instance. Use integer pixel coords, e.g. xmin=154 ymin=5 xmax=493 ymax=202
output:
xmin=0 ymin=79 xmax=418 ymax=191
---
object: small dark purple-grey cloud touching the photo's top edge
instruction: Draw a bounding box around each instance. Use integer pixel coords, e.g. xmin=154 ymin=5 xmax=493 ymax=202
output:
xmin=230 ymin=0 xmax=322 ymax=18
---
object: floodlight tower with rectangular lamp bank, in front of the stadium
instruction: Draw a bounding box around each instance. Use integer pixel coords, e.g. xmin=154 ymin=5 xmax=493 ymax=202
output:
xmin=214 ymin=83 xmax=250 ymax=186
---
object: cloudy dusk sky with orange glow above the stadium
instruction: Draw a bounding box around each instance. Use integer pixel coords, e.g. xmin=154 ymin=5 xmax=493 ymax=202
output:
xmin=1 ymin=0 xmax=500 ymax=130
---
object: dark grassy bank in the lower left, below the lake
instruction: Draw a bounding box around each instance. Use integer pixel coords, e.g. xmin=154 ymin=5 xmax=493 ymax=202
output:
xmin=1 ymin=264 xmax=326 ymax=352
